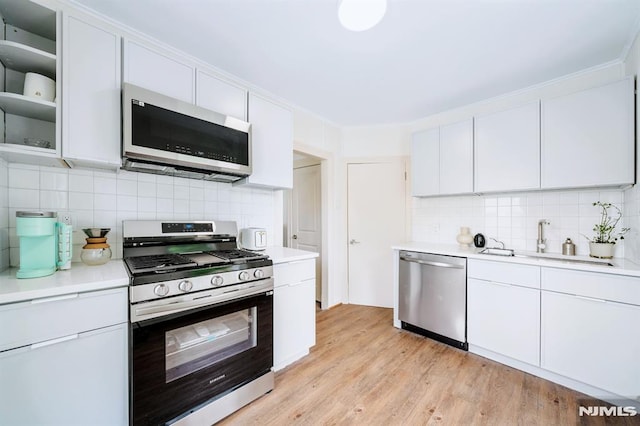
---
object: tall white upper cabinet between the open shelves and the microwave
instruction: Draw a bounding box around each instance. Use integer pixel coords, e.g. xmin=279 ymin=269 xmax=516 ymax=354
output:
xmin=62 ymin=15 xmax=121 ymax=169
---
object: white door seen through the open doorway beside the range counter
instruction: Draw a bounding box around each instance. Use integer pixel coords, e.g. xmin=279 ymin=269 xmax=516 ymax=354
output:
xmin=289 ymin=164 xmax=322 ymax=302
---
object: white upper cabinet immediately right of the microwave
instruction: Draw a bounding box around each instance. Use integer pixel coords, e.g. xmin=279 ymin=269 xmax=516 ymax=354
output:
xmin=236 ymin=93 xmax=293 ymax=189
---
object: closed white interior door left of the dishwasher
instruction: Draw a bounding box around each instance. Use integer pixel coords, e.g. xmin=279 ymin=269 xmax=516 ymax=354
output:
xmin=347 ymin=161 xmax=406 ymax=308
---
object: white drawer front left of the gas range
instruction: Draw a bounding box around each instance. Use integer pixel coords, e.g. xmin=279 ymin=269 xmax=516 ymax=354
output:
xmin=0 ymin=287 xmax=128 ymax=351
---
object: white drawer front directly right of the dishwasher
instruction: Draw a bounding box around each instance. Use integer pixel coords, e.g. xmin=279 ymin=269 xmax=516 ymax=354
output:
xmin=467 ymin=259 xmax=540 ymax=288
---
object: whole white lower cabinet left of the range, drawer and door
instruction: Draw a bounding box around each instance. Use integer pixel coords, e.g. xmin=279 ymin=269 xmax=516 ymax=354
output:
xmin=0 ymin=288 xmax=129 ymax=425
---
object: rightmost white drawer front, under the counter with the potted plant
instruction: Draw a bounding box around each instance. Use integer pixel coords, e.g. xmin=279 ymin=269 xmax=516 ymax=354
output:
xmin=542 ymin=268 xmax=640 ymax=305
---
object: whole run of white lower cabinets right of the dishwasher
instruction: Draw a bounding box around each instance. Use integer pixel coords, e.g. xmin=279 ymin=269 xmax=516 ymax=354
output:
xmin=467 ymin=259 xmax=640 ymax=401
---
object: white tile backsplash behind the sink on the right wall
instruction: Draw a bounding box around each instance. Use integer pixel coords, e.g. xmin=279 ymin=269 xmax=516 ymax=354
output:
xmin=411 ymin=189 xmax=628 ymax=257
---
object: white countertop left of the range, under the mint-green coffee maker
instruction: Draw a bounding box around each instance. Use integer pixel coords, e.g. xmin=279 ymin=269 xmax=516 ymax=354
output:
xmin=0 ymin=259 xmax=129 ymax=305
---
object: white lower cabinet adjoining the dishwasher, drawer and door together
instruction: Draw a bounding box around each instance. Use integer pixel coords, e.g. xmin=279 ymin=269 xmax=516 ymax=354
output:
xmin=467 ymin=259 xmax=540 ymax=366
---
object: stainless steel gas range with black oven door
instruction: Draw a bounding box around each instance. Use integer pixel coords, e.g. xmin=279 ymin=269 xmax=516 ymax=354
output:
xmin=123 ymin=221 xmax=274 ymax=425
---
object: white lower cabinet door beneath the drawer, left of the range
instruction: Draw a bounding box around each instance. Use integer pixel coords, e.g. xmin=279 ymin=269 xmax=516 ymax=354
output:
xmin=0 ymin=324 xmax=129 ymax=426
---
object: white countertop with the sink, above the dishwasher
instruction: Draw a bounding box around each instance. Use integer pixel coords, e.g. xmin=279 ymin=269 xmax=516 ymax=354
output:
xmin=392 ymin=241 xmax=640 ymax=277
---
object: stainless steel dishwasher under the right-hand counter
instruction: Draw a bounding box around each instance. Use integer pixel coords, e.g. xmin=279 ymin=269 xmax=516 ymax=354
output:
xmin=398 ymin=251 xmax=469 ymax=350
